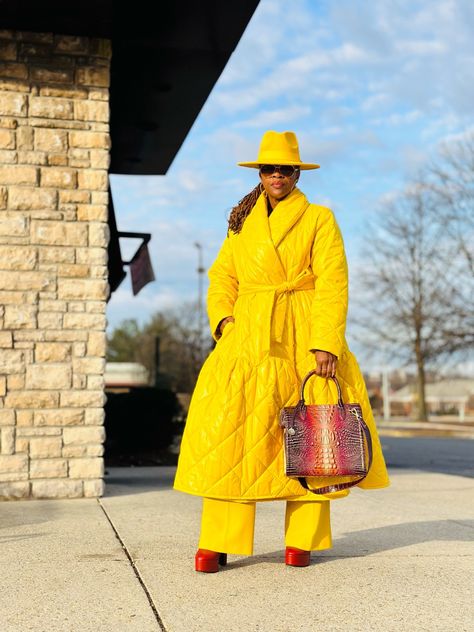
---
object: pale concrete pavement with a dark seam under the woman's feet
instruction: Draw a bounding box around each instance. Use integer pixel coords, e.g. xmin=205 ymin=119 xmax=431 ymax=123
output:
xmin=0 ymin=467 xmax=474 ymax=632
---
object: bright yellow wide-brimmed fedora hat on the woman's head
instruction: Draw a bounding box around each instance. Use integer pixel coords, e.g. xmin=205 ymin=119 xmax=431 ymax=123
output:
xmin=237 ymin=130 xmax=319 ymax=170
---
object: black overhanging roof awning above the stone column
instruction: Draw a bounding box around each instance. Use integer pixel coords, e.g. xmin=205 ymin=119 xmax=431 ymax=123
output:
xmin=0 ymin=0 xmax=258 ymax=175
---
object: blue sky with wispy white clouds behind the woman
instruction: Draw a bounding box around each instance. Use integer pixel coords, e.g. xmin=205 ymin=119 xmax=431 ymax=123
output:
xmin=107 ymin=0 xmax=474 ymax=350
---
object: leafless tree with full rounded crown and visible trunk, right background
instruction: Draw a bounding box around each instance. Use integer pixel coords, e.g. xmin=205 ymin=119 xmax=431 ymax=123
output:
xmin=357 ymin=174 xmax=474 ymax=420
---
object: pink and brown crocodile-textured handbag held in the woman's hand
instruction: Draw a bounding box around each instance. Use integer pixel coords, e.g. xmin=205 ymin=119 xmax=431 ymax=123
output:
xmin=280 ymin=371 xmax=372 ymax=494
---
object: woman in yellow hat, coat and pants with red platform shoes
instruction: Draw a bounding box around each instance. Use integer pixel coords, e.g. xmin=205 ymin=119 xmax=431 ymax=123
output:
xmin=174 ymin=131 xmax=389 ymax=572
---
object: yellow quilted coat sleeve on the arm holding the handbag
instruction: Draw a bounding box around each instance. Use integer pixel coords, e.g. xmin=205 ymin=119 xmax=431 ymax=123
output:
xmin=310 ymin=207 xmax=348 ymax=357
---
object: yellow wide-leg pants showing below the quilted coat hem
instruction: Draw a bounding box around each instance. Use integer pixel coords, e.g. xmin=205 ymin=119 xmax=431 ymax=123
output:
xmin=199 ymin=498 xmax=332 ymax=555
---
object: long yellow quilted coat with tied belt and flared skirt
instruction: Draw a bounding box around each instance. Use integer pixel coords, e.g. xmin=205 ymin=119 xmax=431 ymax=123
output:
xmin=174 ymin=189 xmax=389 ymax=501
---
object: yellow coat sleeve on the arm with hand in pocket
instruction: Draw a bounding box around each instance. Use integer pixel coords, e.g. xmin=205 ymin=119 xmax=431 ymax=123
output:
xmin=207 ymin=237 xmax=239 ymax=340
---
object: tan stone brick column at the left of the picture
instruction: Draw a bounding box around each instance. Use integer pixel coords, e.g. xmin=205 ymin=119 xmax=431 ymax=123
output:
xmin=0 ymin=31 xmax=111 ymax=498
